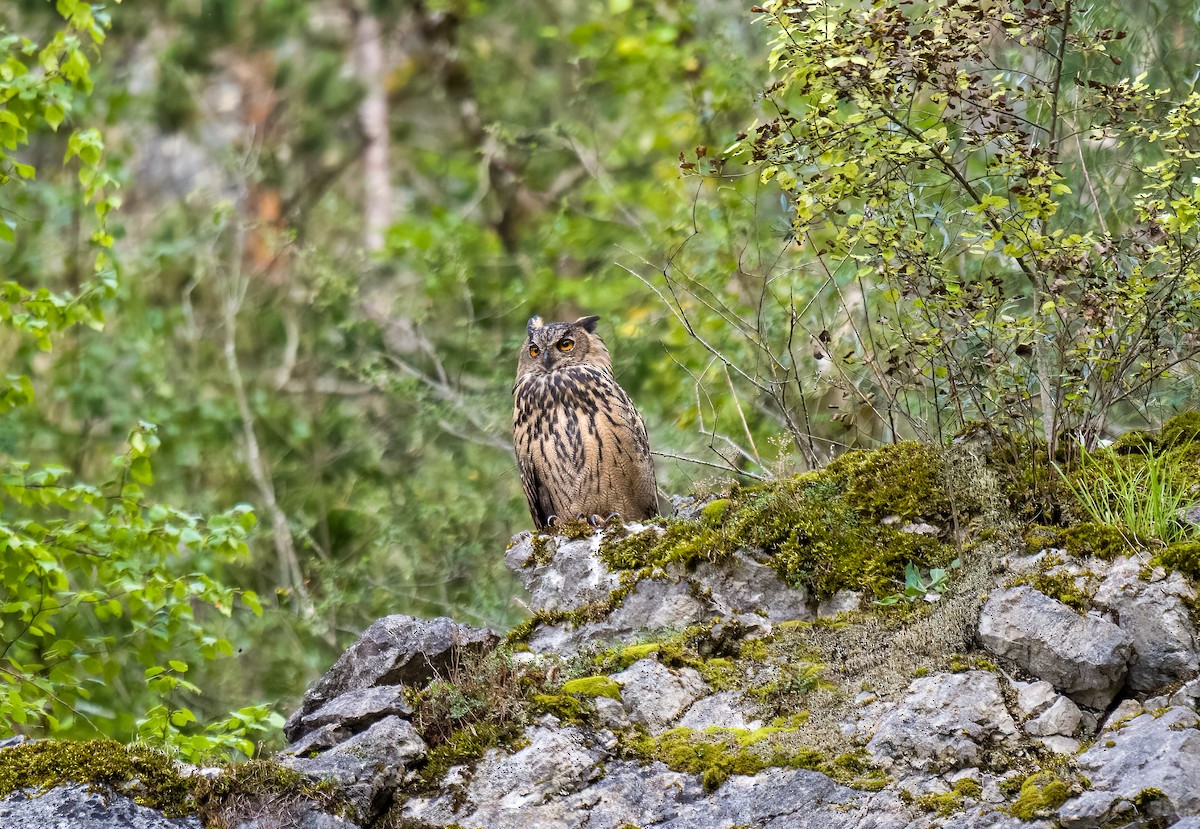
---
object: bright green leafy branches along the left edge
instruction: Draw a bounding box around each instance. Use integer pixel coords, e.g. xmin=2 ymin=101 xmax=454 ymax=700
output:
xmin=0 ymin=0 xmax=264 ymax=758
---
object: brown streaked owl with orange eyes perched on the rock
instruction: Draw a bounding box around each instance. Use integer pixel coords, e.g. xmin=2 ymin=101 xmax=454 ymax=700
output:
xmin=512 ymin=317 xmax=659 ymax=529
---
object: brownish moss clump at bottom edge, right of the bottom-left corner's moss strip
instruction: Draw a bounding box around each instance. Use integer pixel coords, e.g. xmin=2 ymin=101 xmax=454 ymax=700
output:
xmin=196 ymin=759 xmax=354 ymax=829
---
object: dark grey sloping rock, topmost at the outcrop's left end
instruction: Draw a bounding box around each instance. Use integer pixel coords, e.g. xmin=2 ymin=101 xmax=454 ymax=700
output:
xmin=283 ymin=614 xmax=499 ymax=741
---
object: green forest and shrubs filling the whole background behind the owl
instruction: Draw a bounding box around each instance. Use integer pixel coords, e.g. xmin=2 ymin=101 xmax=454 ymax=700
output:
xmin=7 ymin=0 xmax=1200 ymax=753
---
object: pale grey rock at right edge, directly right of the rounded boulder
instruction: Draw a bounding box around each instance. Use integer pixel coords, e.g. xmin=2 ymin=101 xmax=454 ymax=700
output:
xmin=1094 ymin=558 xmax=1200 ymax=692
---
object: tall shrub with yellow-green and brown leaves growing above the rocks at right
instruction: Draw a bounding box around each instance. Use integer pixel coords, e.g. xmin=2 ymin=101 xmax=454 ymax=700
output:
xmin=638 ymin=0 xmax=1200 ymax=463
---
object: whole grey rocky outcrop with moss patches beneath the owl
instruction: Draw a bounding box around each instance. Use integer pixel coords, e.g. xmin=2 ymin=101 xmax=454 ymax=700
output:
xmin=0 ymin=460 xmax=1200 ymax=829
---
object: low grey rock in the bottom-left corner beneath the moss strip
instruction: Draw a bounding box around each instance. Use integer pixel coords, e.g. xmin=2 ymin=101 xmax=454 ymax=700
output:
xmin=0 ymin=786 xmax=200 ymax=829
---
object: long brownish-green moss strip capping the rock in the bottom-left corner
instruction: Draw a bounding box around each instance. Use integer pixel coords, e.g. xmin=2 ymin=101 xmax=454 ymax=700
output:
xmin=0 ymin=740 xmax=196 ymax=817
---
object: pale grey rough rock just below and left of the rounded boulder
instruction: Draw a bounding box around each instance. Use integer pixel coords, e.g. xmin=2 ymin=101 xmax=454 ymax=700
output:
xmin=866 ymin=671 xmax=1018 ymax=771
